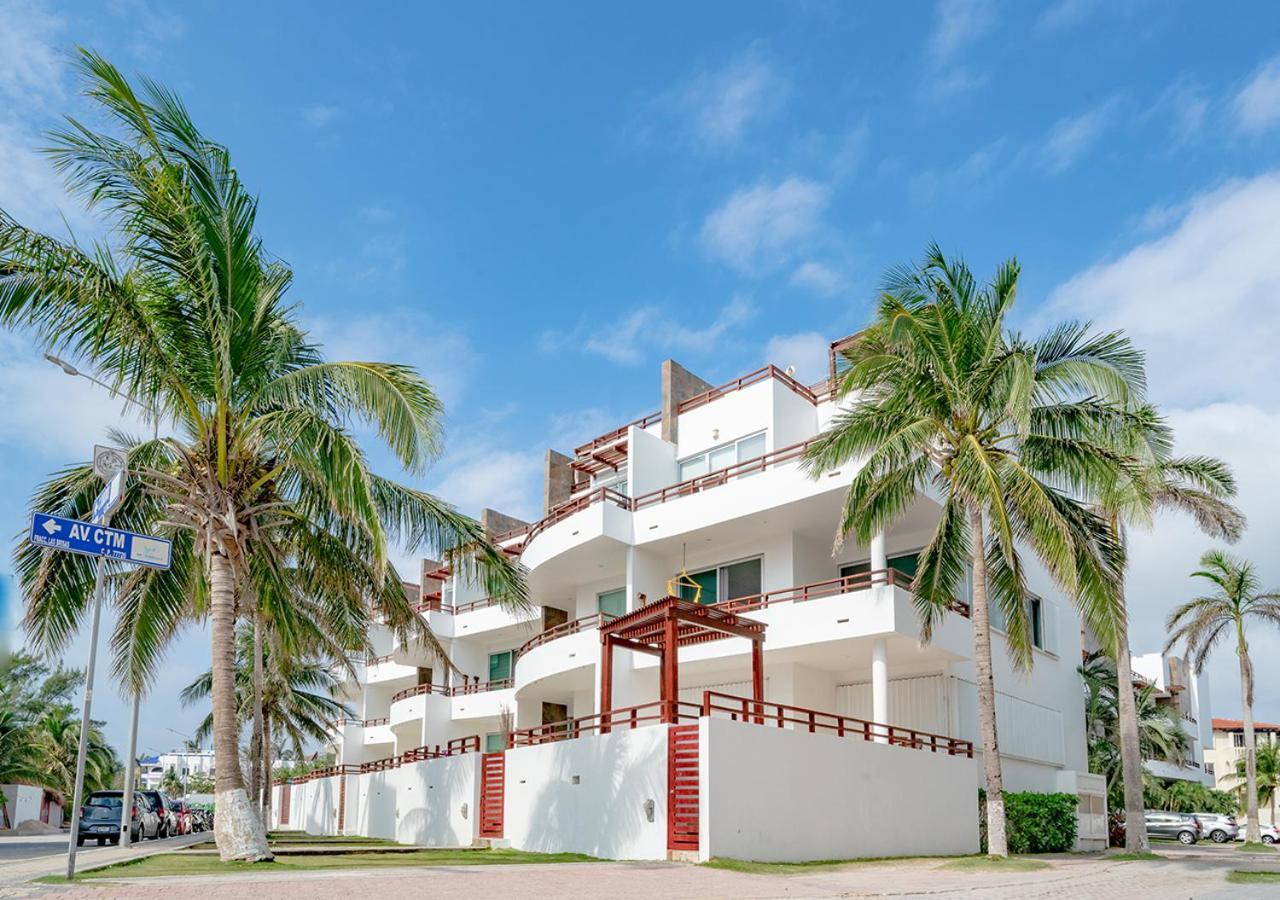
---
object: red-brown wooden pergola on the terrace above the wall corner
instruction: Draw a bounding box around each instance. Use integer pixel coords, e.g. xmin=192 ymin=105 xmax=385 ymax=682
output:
xmin=599 ymin=597 xmax=765 ymax=731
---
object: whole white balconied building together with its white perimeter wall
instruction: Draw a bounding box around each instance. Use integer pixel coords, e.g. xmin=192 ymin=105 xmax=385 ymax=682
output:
xmin=276 ymin=342 xmax=1106 ymax=859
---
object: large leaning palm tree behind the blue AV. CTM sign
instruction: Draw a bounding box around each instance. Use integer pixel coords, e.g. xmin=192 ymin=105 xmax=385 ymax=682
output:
xmin=0 ymin=51 xmax=524 ymax=859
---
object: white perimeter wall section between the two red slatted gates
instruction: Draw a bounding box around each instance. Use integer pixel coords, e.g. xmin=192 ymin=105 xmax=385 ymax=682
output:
xmin=504 ymin=726 xmax=665 ymax=859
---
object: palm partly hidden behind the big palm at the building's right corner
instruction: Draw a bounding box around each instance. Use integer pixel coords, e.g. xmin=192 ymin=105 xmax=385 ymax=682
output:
xmin=1097 ymin=405 xmax=1244 ymax=853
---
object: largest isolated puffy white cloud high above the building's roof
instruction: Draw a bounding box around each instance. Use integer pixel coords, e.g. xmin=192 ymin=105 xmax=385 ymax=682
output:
xmin=700 ymin=175 xmax=831 ymax=274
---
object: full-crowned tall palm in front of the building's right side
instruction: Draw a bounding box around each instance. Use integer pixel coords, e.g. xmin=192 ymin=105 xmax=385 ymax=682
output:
xmin=804 ymin=246 xmax=1144 ymax=855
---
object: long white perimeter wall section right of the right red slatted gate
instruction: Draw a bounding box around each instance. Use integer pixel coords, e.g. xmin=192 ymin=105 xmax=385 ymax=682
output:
xmin=701 ymin=718 xmax=978 ymax=862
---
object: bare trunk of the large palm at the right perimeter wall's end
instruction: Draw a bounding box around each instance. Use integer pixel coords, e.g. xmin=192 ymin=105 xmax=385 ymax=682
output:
xmin=969 ymin=506 xmax=1009 ymax=856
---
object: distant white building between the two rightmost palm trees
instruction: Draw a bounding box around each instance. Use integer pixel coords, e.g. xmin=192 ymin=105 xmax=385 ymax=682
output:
xmin=1130 ymin=653 xmax=1213 ymax=787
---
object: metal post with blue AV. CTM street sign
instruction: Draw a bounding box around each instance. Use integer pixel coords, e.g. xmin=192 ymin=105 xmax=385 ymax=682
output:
xmin=27 ymin=447 xmax=173 ymax=881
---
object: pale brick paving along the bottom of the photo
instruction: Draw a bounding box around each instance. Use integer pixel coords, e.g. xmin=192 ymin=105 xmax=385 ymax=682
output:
xmin=10 ymin=853 xmax=1280 ymax=900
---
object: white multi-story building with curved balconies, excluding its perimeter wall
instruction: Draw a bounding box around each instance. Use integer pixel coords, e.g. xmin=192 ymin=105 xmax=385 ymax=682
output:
xmin=285 ymin=342 xmax=1106 ymax=855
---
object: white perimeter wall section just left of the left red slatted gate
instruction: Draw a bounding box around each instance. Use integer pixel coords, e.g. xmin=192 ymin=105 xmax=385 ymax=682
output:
xmin=393 ymin=753 xmax=480 ymax=848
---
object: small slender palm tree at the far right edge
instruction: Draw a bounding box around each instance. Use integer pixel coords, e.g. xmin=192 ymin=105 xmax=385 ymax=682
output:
xmin=1165 ymin=550 xmax=1280 ymax=844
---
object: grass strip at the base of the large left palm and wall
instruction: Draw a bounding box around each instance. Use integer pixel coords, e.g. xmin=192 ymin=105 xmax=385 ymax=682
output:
xmin=37 ymin=849 xmax=596 ymax=885
